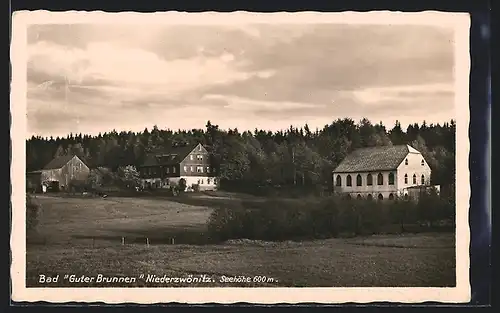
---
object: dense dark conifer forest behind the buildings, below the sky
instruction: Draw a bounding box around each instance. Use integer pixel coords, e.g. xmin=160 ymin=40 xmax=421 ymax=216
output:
xmin=26 ymin=118 xmax=456 ymax=195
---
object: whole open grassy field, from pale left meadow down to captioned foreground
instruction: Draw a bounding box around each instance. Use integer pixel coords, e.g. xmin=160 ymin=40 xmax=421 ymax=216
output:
xmin=27 ymin=196 xmax=455 ymax=287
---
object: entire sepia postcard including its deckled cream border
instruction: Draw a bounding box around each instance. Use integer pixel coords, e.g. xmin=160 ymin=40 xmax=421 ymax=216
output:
xmin=10 ymin=11 xmax=470 ymax=304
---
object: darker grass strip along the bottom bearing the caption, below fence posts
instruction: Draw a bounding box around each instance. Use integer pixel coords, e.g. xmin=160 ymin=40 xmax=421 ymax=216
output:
xmin=27 ymin=234 xmax=455 ymax=287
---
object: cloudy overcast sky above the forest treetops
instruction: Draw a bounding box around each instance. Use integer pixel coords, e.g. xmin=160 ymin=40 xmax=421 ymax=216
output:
xmin=27 ymin=24 xmax=455 ymax=137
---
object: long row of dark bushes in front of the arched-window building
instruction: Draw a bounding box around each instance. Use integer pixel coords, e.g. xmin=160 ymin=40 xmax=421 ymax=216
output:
xmin=208 ymin=190 xmax=455 ymax=240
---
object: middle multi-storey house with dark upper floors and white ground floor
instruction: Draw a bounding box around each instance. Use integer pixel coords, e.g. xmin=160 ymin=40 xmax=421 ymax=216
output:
xmin=139 ymin=144 xmax=218 ymax=190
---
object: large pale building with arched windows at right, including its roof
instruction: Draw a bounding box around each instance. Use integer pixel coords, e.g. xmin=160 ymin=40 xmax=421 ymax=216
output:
xmin=333 ymin=145 xmax=439 ymax=200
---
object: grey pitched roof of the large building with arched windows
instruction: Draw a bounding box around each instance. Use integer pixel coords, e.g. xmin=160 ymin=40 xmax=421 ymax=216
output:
xmin=334 ymin=145 xmax=412 ymax=173
